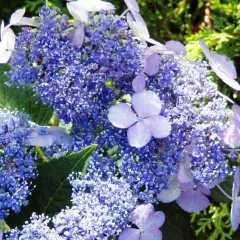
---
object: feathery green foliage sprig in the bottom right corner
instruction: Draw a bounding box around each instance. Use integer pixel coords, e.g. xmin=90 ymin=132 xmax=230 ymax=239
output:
xmin=191 ymin=203 xmax=233 ymax=240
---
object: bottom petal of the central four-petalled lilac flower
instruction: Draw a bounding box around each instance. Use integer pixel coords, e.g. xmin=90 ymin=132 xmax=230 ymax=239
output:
xmin=127 ymin=122 xmax=152 ymax=148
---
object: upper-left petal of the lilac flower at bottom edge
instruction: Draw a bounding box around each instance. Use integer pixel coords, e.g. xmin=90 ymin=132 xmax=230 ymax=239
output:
xmin=130 ymin=203 xmax=154 ymax=229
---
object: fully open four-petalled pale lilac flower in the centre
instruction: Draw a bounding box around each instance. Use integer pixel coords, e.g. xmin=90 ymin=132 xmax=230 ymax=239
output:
xmin=108 ymin=90 xmax=171 ymax=148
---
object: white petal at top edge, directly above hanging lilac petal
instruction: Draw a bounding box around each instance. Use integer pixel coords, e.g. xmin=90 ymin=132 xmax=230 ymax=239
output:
xmin=67 ymin=2 xmax=88 ymax=23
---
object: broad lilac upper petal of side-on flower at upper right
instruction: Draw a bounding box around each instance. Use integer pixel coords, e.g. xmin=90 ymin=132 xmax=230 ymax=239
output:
xmin=211 ymin=53 xmax=237 ymax=79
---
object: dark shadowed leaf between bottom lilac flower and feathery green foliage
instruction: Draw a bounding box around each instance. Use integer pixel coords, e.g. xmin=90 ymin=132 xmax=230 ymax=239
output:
xmin=156 ymin=203 xmax=197 ymax=240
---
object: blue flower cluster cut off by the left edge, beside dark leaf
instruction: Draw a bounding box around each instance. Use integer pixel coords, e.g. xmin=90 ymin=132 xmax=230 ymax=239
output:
xmin=0 ymin=111 xmax=36 ymax=219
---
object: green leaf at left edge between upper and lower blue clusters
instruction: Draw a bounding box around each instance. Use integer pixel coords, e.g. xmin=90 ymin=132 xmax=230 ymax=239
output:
xmin=0 ymin=65 xmax=53 ymax=125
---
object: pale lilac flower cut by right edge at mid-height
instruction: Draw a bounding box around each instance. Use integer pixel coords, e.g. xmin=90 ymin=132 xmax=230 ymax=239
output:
xmin=221 ymin=104 xmax=240 ymax=148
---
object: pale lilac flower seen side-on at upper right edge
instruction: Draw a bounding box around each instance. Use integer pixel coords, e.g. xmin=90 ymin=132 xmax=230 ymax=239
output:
xmin=199 ymin=40 xmax=240 ymax=91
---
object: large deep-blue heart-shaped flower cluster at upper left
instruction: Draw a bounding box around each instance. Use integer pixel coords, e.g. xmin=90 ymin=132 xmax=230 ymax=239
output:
xmin=10 ymin=7 xmax=143 ymax=125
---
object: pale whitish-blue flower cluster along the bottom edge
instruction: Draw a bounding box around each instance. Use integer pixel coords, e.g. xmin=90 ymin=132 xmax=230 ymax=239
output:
xmin=9 ymin=174 xmax=137 ymax=240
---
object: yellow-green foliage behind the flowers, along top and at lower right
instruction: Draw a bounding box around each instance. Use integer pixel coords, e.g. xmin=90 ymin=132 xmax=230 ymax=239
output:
xmin=0 ymin=0 xmax=240 ymax=240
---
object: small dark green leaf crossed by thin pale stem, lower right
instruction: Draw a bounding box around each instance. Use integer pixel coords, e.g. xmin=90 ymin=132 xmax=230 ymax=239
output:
xmin=211 ymin=176 xmax=233 ymax=203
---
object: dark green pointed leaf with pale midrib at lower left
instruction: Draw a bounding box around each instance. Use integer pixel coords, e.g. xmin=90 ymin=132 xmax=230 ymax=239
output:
xmin=6 ymin=145 xmax=97 ymax=227
